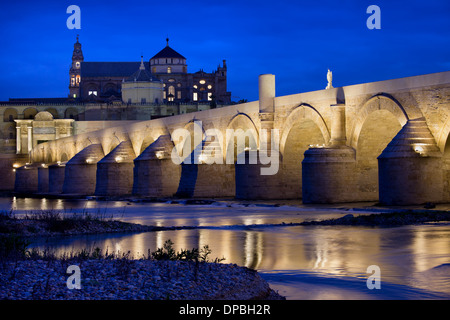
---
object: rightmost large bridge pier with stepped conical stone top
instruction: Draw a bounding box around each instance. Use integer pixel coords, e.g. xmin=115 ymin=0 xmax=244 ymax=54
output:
xmin=378 ymin=118 xmax=444 ymax=205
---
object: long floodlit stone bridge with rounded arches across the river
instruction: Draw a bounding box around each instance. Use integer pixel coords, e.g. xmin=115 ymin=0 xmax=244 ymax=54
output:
xmin=15 ymin=72 xmax=450 ymax=205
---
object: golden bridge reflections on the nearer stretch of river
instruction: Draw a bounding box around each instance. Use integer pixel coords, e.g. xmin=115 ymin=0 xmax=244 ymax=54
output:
xmin=29 ymin=226 xmax=450 ymax=293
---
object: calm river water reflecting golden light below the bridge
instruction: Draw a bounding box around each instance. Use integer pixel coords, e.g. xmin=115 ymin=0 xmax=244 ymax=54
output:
xmin=0 ymin=198 xmax=450 ymax=299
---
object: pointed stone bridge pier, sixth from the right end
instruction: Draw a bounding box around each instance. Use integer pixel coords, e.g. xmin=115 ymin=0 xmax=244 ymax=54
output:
xmin=95 ymin=141 xmax=136 ymax=196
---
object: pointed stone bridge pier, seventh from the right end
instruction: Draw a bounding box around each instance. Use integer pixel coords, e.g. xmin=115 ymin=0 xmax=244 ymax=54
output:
xmin=63 ymin=144 xmax=104 ymax=195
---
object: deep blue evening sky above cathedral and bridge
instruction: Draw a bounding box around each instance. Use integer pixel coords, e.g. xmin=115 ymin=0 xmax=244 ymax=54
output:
xmin=0 ymin=0 xmax=450 ymax=101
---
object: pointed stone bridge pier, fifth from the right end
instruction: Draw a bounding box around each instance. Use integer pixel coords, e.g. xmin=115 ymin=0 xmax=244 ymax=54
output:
xmin=133 ymin=135 xmax=181 ymax=197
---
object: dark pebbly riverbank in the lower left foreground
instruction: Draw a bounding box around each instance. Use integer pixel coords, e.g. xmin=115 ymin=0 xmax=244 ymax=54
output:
xmin=0 ymin=259 xmax=284 ymax=300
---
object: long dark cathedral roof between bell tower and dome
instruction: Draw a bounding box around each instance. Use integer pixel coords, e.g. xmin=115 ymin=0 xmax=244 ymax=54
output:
xmin=81 ymin=62 xmax=150 ymax=78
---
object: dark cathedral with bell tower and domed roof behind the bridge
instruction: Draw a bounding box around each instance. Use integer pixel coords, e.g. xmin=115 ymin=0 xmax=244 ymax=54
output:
xmin=69 ymin=37 xmax=231 ymax=104
